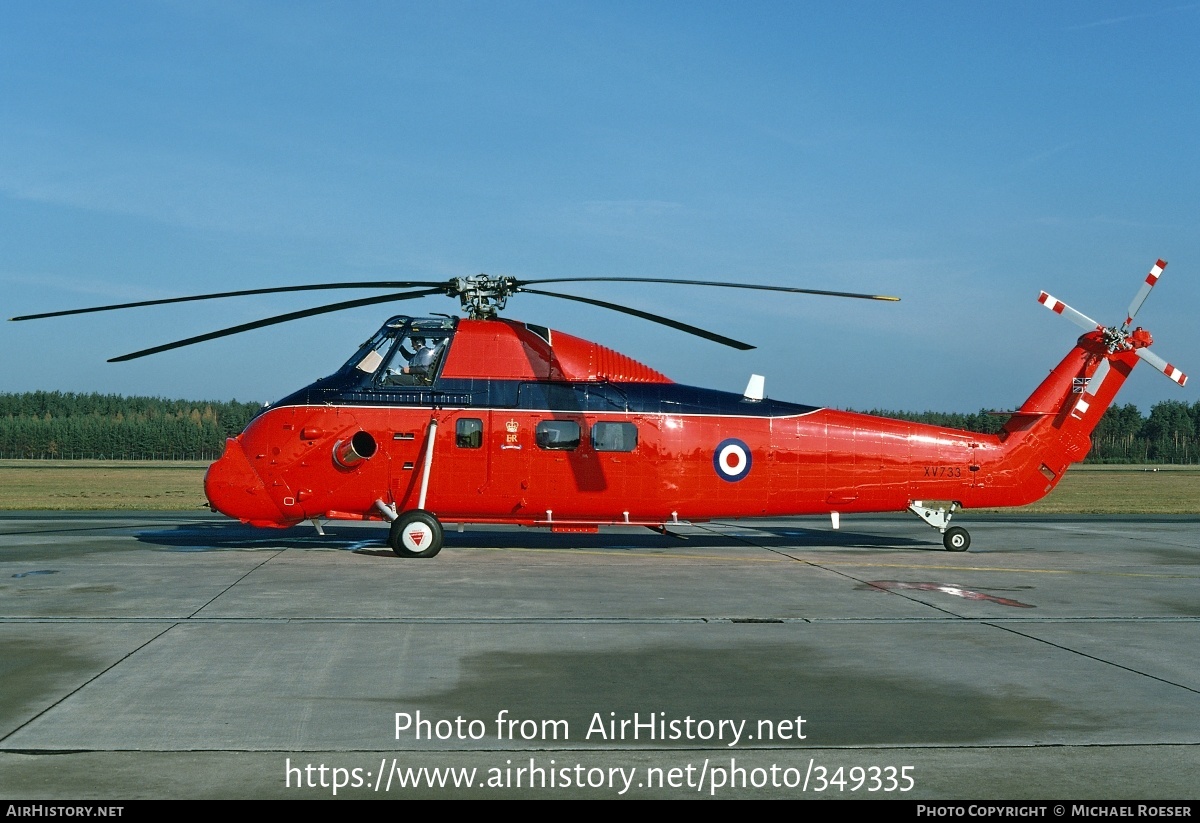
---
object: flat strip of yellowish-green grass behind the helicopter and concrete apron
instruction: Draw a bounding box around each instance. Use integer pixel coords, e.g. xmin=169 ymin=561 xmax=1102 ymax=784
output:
xmin=0 ymin=459 xmax=1200 ymax=515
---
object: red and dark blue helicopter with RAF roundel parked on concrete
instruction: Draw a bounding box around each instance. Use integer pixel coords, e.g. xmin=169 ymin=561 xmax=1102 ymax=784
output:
xmin=12 ymin=260 xmax=1187 ymax=557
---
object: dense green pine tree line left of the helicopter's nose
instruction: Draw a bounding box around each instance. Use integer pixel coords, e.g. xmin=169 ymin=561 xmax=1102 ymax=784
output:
xmin=0 ymin=391 xmax=260 ymax=459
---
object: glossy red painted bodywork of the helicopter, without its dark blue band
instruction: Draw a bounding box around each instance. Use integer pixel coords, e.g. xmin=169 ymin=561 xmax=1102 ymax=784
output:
xmin=206 ymin=320 xmax=1139 ymax=527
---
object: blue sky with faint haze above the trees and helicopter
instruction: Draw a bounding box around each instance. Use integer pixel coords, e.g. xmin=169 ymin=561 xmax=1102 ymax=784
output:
xmin=0 ymin=0 xmax=1200 ymax=410
